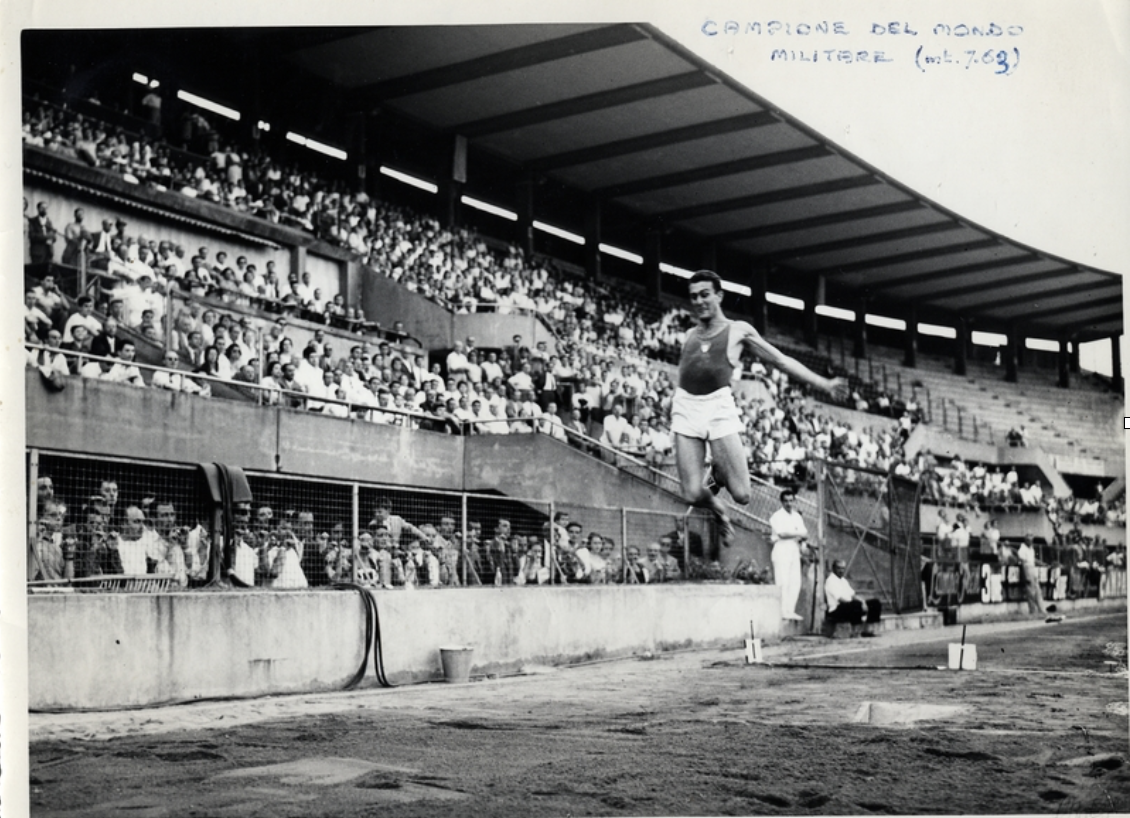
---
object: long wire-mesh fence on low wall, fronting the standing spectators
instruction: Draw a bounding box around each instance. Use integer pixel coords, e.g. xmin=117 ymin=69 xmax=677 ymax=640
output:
xmin=28 ymin=450 xmax=745 ymax=591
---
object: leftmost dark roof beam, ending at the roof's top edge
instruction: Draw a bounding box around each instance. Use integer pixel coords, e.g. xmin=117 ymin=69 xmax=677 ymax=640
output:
xmin=355 ymin=24 xmax=647 ymax=101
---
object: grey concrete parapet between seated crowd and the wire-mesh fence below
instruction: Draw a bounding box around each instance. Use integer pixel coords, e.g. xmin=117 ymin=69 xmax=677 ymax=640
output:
xmin=25 ymin=369 xmax=714 ymax=514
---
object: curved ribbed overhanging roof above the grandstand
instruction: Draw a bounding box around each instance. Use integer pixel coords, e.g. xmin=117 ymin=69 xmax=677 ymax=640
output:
xmin=289 ymin=25 xmax=1122 ymax=338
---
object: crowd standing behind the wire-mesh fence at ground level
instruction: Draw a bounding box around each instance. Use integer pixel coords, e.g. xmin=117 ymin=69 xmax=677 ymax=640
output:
xmin=28 ymin=476 xmax=768 ymax=589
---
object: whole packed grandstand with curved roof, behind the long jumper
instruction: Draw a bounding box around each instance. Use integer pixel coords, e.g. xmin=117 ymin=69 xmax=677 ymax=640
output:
xmin=21 ymin=24 xmax=1125 ymax=708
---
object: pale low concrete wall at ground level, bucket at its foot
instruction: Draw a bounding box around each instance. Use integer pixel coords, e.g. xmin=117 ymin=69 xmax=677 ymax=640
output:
xmin=28 ymin=584 xmax=781 ymax=710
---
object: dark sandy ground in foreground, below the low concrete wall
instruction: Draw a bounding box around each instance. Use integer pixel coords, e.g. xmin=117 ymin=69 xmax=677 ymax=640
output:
xmin=29 ymin=610 xmax=1130 ymax=818
